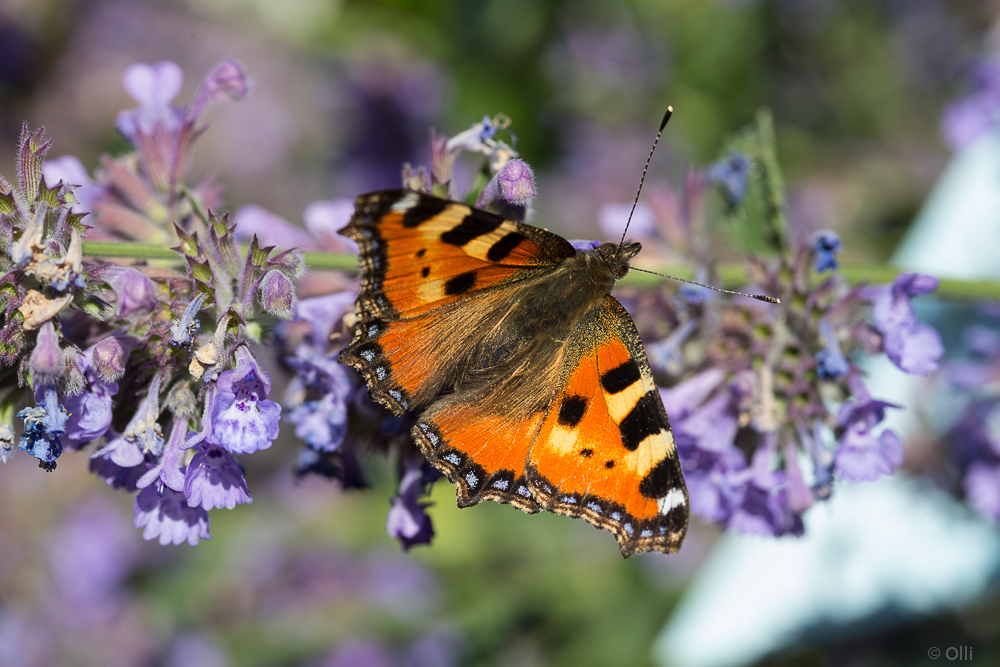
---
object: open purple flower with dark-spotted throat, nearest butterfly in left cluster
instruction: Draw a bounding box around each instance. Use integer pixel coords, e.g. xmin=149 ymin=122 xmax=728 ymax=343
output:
xmin=211 ymin=348 xmax=281 ymax=454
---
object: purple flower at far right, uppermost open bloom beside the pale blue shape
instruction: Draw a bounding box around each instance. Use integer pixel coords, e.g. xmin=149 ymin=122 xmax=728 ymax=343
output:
xmin=864 ymin=273 xmax=944 ymax=375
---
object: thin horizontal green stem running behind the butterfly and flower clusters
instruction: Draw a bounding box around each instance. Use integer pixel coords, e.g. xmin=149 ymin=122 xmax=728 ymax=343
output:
xmin=83 ymin=241 xmax=1000 ymax=301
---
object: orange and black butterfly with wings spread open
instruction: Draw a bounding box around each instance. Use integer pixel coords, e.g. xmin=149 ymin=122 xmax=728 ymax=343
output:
xmin=339 ymin=189 xmax=690 ymax=557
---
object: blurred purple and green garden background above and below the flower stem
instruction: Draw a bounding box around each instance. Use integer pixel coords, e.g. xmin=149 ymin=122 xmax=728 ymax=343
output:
xmin=0 ymin=0 xmax=1000 ymax=666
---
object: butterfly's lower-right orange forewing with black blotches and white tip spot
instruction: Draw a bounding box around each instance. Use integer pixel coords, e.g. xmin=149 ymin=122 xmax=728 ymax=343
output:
xmin=527 ymin=296 xmax=688 ymax=556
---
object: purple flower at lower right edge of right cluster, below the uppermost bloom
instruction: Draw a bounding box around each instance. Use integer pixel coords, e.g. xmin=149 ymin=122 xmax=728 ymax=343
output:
xmin=834 ymin=399 xmax=903 ymax=481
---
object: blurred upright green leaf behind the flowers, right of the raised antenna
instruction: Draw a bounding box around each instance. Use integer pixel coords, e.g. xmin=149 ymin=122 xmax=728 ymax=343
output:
xmin=721 ymin=108 xmax=788 ymax=256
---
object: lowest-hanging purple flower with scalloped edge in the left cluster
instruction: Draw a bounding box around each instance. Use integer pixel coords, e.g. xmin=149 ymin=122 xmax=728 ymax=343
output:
xmin=132 ymin=485 xmax=212 ymax=546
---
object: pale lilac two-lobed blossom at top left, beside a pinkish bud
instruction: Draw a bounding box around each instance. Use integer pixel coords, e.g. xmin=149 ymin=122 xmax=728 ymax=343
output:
xmin=118 ymin=60 xmax=184 ymax=144
